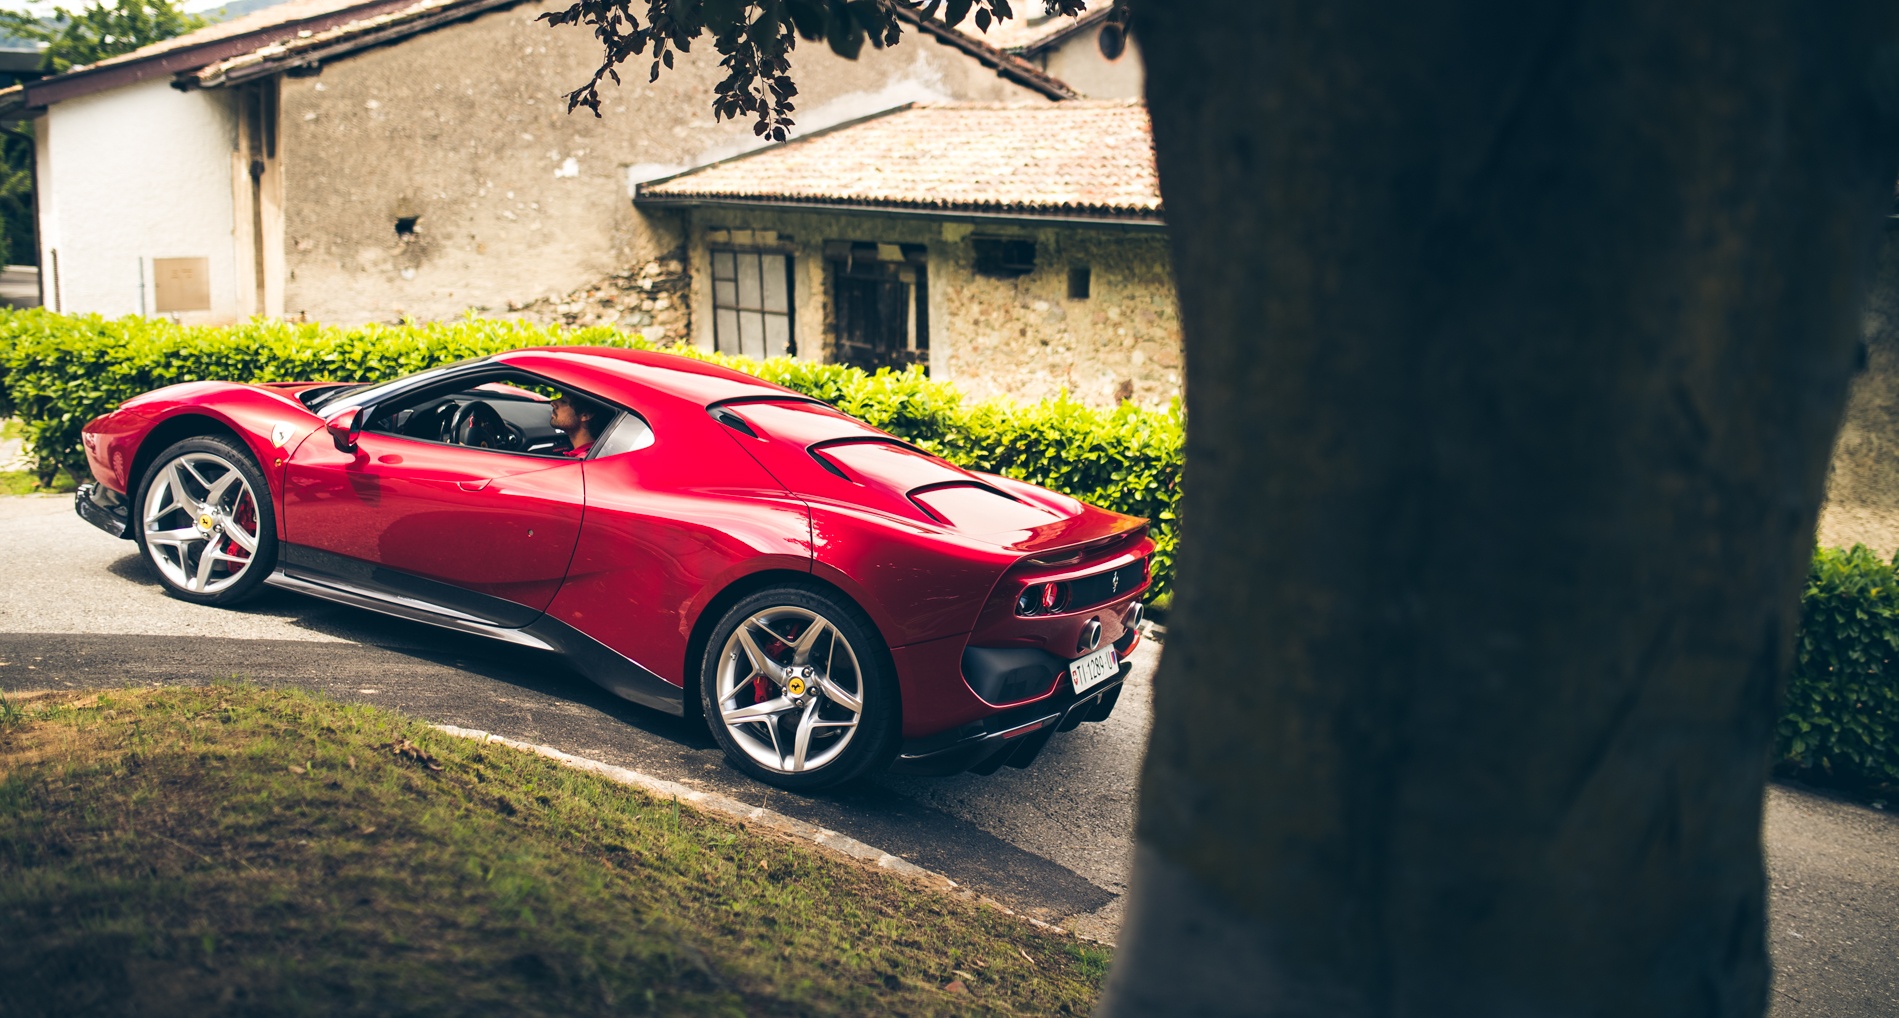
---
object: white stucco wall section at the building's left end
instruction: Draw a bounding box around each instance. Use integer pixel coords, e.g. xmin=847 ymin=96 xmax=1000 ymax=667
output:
xmin=38 ymin=78 xmax=251 ymax=321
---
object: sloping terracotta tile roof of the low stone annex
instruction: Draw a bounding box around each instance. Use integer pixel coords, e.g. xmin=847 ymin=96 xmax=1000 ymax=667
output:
xmin=636 ymin=101 xmax=1160 ymax=222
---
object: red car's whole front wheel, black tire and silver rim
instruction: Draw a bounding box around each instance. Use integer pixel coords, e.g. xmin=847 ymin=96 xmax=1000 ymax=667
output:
xmin=131 ymin=435 xmax=277 ymax=606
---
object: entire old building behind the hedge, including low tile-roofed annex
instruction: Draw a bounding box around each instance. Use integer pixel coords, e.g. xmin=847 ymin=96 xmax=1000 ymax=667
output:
xmin=0 ymin=0 xmax=1181 ymax=405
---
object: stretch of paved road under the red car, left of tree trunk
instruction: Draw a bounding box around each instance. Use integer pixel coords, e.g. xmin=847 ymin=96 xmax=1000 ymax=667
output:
xmin=0 ymin=496 xmax=1158 ymax=938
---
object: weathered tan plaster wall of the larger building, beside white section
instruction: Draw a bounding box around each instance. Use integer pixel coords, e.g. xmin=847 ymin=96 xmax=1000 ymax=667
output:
xmin=279 ymin=2 xmax=1039 ymax=323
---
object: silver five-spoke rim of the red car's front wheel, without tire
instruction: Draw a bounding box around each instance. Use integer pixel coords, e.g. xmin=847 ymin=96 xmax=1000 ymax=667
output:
xmin=141 ymin=452 xmax=262 ymax=594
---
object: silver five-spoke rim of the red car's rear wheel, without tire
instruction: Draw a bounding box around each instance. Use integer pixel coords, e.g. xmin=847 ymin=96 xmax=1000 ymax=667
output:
xmin=718 ymin=606 xmax=866 ymax=775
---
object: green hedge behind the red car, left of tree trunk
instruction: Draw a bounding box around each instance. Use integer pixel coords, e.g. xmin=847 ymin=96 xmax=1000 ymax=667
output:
xmin=0 ymin=310 xmax=1183 ymax=596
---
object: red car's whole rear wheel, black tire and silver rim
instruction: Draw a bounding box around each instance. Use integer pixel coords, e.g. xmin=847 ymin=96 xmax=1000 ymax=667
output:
xmin=699 ymin=583 xmax=902 ymax=792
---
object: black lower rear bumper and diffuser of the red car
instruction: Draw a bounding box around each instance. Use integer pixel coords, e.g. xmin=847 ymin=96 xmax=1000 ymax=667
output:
xmin=891 ymin=661 xmax=1134 ymax=775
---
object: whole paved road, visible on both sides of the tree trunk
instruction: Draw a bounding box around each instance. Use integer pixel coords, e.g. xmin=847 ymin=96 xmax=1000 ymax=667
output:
xmin=0 ymin=498 xmax=1899 ymax=1018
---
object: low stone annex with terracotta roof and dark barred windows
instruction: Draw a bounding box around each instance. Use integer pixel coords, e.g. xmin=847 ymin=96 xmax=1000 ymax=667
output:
xmin=634 ymin=101 xmax=1181 ymax=406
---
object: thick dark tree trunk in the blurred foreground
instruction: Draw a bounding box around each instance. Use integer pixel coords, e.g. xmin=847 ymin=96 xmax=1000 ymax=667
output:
xmin=1101 ymin=0 xmax=1899 ymax=1018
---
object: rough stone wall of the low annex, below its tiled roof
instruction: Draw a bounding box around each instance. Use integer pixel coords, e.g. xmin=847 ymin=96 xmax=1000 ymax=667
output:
xmin=653 ymin=207 xmax=1181 ymax=406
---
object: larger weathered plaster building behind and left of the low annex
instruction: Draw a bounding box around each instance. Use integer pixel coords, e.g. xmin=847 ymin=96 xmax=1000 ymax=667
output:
xmin=0 ymin=0 xmax=1075 ymax=332
